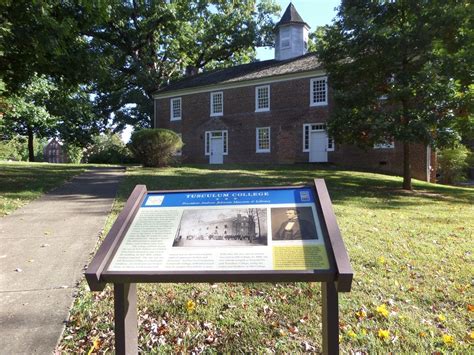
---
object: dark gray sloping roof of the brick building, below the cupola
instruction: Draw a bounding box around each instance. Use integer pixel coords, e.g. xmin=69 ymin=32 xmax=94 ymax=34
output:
xmin=155 ymin=53 xmax=321 ymax=94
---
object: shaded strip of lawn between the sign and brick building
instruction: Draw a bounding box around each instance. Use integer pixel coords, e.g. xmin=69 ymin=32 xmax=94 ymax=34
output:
xmin=119 ymin=165 xmax=474 ymax=209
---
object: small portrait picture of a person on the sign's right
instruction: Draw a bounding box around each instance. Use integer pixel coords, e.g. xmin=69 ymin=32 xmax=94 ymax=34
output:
xmin=271 ymin=207 xmax=319 ymax=240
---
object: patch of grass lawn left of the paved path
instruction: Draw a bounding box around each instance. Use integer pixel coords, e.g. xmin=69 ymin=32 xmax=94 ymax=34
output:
xmin=0 ymin=162 xmax=88 ymax=217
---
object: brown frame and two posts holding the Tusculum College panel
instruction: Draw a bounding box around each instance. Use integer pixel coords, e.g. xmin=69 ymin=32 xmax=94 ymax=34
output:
xmin=85 ymin=179 xmax=353 ymax=354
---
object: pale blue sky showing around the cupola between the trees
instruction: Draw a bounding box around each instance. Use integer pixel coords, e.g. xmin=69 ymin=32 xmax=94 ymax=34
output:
xmin=257 ymin=0 xmax=341 ymax=60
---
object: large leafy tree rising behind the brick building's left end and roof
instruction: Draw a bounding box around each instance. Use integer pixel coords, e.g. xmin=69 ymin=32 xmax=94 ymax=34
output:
xmin=70 ymin=0 xmax=279 ymax=129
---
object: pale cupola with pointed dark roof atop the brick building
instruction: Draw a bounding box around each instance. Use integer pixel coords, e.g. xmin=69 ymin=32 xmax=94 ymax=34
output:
xmin=275 ymin=2 xmax=310 ymax=60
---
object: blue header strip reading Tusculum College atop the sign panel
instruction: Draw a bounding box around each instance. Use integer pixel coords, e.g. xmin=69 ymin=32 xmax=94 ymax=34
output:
xmin=142 ymin=187 xmax=314 ymax=207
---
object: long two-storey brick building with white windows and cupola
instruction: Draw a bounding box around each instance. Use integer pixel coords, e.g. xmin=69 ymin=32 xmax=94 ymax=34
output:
xmin=154 ymin=4 xmax=434 ymax=184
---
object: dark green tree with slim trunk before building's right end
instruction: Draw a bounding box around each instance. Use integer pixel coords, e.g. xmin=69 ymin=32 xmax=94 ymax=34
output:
xmin=318 ymin=0 xmax=472 ymax=189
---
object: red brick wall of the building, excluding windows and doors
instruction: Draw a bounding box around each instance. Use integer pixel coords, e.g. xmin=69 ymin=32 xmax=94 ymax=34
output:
xmin=155 ymin=78 xmax=434 ymax=180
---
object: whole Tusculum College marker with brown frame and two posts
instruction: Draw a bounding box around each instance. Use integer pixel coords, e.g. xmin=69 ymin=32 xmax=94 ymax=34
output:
xmin=86 ymin=180 xmax=353 ymax=353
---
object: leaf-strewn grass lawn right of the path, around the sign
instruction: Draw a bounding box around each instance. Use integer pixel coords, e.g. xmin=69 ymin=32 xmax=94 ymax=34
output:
xmin=59 ymin=165 xmax=474 ymax=353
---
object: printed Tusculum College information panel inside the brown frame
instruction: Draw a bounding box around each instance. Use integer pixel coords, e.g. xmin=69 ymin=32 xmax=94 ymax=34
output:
xmin=107 ymin=188 xmax=329 ymax=272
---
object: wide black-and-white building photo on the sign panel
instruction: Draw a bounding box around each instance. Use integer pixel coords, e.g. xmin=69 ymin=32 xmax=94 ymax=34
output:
xmin=173 ymin=208 xmax=268 ymax=247
